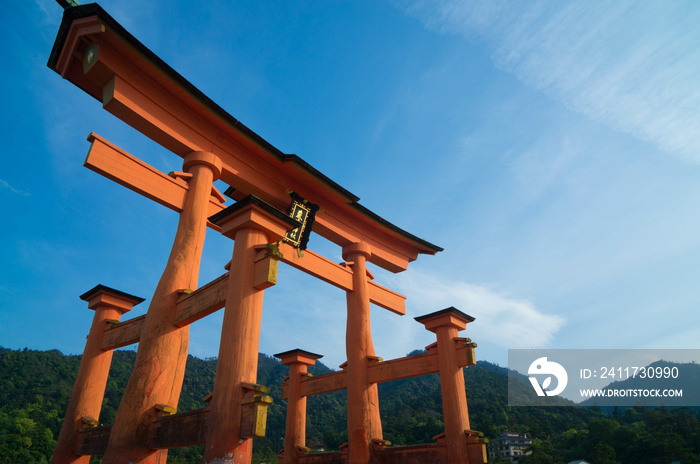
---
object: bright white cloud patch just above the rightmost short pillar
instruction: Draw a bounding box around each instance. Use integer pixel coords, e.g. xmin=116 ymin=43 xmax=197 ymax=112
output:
xmin=391 ymin=270 xmax=565 ymax=348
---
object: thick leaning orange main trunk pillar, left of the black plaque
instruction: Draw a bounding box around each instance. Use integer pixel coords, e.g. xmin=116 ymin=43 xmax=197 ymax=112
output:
xmin=102 ymin=152 xmax=221 ymax=464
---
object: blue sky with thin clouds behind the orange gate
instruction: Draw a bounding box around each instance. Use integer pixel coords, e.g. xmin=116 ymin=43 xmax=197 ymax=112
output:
xmin=0 ymin=0 xmax=700 ymax=367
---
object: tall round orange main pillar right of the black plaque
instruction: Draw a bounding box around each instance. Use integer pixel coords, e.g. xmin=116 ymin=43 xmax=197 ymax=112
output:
xmin=343 ymin=243 xmax=382 ymax=464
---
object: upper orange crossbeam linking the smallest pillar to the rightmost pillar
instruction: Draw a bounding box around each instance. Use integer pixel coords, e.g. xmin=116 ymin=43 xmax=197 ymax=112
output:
xmin=282 ymin=339 xmax=475 ymax=400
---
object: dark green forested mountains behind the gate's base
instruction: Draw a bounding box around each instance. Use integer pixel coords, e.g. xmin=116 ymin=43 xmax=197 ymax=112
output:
xmin=0 ymin=348 xmax=700 ymax=464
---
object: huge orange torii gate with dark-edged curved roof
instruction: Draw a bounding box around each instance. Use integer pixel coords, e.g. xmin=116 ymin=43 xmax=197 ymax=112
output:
xmin=48 ymin=4 xmax=483 ymax=463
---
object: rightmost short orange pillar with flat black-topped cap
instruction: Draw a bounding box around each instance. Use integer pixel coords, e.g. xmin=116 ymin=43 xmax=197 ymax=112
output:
xmin=416 ymin=307 xmax=474 ymax=464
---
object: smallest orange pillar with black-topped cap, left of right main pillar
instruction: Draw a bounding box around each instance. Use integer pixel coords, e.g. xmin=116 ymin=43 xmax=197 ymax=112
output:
xmin=275 ymin=348 xmax=323 ymax=464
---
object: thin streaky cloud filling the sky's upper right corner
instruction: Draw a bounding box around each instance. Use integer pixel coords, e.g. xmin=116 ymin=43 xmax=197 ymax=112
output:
xmin=401 ymin=0 xmax=700 ymax=163
